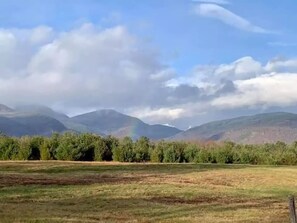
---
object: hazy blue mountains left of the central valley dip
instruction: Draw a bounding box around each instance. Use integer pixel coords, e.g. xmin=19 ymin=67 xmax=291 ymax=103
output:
xmin=0 ymin=105 xmax=181 ymax=140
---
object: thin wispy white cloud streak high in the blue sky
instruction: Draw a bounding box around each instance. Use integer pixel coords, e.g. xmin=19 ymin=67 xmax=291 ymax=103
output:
xmin=194 ymin=3 xmax=270 ymax=33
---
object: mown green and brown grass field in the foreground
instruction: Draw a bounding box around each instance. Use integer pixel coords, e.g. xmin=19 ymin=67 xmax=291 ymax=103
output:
xmin=0 ymin=161 xmax=297 ymax=223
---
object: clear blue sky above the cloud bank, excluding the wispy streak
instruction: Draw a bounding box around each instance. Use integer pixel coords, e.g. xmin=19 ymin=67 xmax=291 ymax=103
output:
xmin=0 ymin=0 xmax=297 ymax=71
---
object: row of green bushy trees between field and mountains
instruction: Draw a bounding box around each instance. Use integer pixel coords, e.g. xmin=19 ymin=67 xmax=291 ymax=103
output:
xmin=0 ymin=133 xmax=297 ymax=165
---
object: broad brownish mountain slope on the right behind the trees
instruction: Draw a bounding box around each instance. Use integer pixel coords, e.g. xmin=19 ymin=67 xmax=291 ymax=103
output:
xmin=172 ymin=112 xmax=297 ymax=143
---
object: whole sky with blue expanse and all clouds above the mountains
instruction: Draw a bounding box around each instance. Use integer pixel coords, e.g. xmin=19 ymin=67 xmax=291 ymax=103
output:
xmin=0 ymin=0 xmax=297 ymax=129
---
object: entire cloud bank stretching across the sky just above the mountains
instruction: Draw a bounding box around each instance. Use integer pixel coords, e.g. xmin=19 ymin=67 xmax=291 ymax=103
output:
xmin=0 ymin=23 xmax=297 ymax=128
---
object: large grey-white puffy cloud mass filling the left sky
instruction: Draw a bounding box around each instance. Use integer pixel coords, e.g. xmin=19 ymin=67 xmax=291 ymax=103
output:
xmin=0 ymin=24 xmax=174 ymax=109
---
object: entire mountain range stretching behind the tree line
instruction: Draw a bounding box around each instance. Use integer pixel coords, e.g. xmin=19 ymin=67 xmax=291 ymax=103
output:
xmin=0 ymin=104 xmax=297 ymax=144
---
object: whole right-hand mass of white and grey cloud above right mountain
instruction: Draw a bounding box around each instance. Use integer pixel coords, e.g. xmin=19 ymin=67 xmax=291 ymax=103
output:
xmin=165 ymin=57 xmax=297 ymax=120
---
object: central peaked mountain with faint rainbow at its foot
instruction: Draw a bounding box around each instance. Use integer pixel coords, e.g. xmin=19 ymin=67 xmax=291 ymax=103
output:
xmin=71 ymin=109 xmax=181 ymax=140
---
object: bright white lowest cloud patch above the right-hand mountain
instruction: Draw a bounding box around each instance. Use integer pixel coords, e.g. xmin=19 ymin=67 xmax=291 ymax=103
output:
xmin=211 ymin=73 xmax=297 ymax=109
